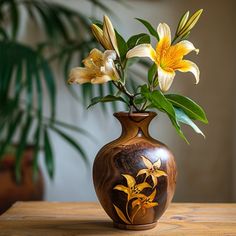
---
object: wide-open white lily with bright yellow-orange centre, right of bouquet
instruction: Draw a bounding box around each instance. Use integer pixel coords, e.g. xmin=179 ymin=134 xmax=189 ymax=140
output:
xmin=126 ymin=23 xmax=200 ymax=92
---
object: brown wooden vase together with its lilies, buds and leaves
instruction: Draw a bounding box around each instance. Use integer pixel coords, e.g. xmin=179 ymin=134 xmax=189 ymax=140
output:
xmin=68 ymin=10 xmax=208 ymax=230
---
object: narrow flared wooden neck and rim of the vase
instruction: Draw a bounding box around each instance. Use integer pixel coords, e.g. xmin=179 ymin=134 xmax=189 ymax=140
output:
xmin=114 ymin=112 xmax=156 ymax=138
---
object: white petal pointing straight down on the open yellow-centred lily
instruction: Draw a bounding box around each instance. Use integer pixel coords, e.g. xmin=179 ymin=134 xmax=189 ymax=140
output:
xmin=158 ymin=66 xmax=175 ymax=92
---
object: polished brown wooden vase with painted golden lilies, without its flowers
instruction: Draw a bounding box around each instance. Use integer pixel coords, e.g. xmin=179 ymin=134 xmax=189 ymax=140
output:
xmin=93 ymin=112 xmax=176 ymax=230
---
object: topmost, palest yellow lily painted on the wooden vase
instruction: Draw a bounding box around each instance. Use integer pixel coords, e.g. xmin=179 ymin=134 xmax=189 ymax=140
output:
xmin=137 ymin=156 xmax=167 ymax=188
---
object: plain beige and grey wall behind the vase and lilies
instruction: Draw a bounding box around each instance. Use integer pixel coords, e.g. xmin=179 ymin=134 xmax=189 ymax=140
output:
xmin=30 ymin=0 xmax=236 ymax=202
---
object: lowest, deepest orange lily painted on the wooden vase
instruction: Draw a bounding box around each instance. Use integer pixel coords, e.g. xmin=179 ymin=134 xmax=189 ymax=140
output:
xmin=131 ymin=189 xmax=158 ymax=218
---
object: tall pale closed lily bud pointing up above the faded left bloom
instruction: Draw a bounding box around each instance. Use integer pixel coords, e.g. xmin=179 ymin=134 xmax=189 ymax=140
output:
xmin=103 ymin=15 xmax=120 ymax=56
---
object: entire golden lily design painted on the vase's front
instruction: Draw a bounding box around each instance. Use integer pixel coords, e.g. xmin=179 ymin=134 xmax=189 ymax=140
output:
xmin=113 ymin=156 xmax=167 ymax=224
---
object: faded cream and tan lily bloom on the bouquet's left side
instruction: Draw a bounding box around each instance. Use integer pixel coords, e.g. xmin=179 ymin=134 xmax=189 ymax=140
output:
xmin=68 ymin=49 xmax=119 ymax=84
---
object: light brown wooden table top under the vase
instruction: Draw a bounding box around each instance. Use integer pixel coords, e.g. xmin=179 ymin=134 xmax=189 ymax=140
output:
xmin=0 ymin=202 xmax=236 ymax=236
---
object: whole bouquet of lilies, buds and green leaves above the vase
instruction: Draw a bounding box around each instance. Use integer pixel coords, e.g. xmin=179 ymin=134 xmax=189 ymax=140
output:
xmin=68 ymin=9 xmax=208 ymax=142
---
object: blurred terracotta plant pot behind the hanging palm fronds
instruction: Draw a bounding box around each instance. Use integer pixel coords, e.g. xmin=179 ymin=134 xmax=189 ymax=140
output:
xmin=0 ymin=146 xmax=44 ymax=214
